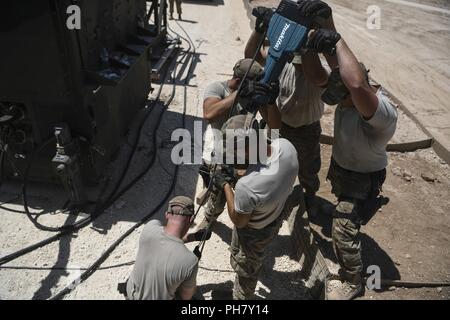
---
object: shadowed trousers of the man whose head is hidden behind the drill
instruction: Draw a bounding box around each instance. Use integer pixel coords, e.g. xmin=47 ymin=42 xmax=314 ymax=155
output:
xmin=280 ymin=121 xmax=322 ymax=194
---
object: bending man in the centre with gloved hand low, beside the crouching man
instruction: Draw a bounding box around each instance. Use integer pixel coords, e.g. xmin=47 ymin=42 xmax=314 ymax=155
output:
xmin=213 ymin=115 xmax=298 ymax=300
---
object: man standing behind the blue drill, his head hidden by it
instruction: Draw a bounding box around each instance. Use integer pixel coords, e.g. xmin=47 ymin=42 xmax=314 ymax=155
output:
xmin=245 ymin=3 xmax=331 ymax=218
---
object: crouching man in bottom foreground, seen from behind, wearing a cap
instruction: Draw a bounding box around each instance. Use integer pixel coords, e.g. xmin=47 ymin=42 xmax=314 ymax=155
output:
xmin=124 ymin=197 xmax=207 ymax=300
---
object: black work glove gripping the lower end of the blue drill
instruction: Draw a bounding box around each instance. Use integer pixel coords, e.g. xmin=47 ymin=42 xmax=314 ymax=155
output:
xmin=239 ymin=80 xmax=280 ymax=112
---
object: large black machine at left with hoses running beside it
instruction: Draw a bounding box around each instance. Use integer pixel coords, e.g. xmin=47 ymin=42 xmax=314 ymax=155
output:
xmin=0 ymin=0 xmax=168 ymax=203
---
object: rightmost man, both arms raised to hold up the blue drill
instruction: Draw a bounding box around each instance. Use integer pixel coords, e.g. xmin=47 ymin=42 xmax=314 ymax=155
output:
xmin=308 ymin=21 xmax=397 ymax=300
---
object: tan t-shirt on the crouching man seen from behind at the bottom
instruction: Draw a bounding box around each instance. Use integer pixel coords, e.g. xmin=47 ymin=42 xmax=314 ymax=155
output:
xmin=127 ymin=220 xmax=198 ymax=300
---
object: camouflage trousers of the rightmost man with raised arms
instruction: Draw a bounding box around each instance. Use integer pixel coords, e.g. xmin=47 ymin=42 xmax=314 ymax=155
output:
xmin=327 ymin=159 xmax=386 ymax=284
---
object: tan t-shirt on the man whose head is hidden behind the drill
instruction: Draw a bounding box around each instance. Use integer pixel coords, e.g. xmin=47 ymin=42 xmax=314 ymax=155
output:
xmin=277 ymin=63 xmax=324 ymax=128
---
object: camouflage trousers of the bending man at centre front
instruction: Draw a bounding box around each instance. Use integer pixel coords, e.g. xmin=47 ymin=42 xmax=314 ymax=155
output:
xmin=230 ymin=214 xmax=283 ymax=300
